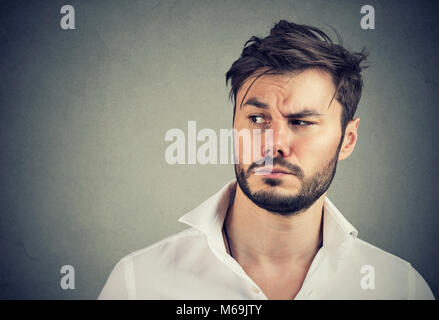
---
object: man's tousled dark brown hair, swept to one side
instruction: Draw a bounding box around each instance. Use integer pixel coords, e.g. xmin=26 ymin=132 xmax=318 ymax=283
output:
xmin=226 ymin=20 xmax=367 ymax=134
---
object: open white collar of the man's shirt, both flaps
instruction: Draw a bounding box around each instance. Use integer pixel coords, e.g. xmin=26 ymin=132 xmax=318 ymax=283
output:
xmin=178 ymin=179 xmax=358 ymax=255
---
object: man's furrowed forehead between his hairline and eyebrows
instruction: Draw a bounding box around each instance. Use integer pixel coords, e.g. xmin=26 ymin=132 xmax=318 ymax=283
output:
xmin=236 ymin=69 xmax=341 ymax=113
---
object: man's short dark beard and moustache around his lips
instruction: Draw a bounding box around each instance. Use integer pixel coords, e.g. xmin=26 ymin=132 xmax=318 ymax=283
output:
xmin=235 ymin=143 xmax=341 ymax=216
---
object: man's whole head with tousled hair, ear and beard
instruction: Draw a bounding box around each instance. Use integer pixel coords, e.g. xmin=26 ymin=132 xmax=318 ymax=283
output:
xmin=226 ymin=20 xmax=366 ymax=215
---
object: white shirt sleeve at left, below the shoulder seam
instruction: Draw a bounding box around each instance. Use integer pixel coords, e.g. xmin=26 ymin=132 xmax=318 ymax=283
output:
xmin=98 ymin=256 xmax=136 ymax=300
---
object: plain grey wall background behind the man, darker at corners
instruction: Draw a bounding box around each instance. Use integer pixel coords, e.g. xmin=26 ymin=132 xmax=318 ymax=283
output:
xmin=0 ymin=0 xmax=439 ymax=299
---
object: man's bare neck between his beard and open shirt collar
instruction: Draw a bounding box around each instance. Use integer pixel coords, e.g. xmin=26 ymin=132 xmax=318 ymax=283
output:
xmin=225 ymin=184 xmax=326 ymax=266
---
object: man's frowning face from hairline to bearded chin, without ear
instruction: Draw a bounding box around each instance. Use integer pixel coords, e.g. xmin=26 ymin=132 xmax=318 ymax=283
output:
xmin=234 ymin=69 xmax=348 ymax=215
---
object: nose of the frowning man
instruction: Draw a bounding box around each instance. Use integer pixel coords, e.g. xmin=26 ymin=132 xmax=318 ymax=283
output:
xmin=265 ymin=122 xmax=293 ymax=158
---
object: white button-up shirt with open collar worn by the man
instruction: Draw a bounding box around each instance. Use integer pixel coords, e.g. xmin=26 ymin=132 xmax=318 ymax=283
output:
xmin=98 ymin=180 xmax=434 ymax=300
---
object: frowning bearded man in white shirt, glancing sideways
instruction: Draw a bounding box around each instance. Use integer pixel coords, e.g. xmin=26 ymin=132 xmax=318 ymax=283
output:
xmin=99 ymin=20 xmax=434 ymax=299
